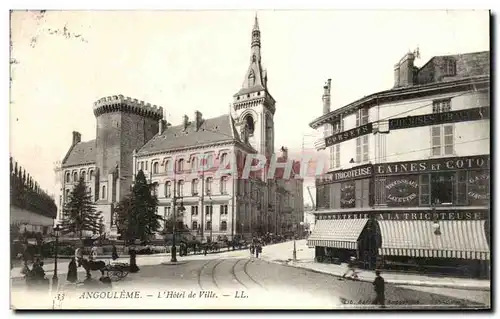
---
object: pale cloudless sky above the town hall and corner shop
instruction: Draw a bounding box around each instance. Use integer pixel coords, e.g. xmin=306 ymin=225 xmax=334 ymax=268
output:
xmin=9 ymin=10 xmax=490 ymax=202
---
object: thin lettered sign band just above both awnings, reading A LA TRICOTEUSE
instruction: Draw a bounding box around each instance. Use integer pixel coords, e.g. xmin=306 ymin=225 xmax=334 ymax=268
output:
xmin=317 ymin=210 xmax=488 ymax=221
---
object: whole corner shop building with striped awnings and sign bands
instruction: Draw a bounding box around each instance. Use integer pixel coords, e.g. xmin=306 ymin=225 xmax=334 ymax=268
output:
xmin=309 ymin=52 xmax=490 ymax=275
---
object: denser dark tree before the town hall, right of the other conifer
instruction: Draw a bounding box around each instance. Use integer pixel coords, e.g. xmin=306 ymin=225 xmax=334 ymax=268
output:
xmin=115 ymin=170 xmax=163 ymax=241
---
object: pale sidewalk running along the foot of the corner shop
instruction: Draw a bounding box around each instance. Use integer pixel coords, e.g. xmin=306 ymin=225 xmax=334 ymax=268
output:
xmin=262 ymin=240 xmax=490 ymax=291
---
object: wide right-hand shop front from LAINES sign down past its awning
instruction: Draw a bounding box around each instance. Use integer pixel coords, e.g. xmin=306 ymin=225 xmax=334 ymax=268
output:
xmin=373 ymin=155 xmax=490 ymax=277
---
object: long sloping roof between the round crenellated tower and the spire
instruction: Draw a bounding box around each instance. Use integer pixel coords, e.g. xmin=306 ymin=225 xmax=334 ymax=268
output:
xmin=138 ymin=115 xmax=246 ymax=155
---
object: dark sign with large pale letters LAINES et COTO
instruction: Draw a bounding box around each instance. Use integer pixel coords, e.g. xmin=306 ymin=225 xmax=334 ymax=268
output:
xmin=374 ymin=155 xmax=490 ymax=175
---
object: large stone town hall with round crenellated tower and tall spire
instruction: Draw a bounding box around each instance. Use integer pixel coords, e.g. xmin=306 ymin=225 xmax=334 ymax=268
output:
xmin=55 ymin=18 xmax=303 ymax=242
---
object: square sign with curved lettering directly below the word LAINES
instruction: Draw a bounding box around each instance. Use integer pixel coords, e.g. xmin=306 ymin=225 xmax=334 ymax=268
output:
xmin=385 ymin=175 xmax=419 ymax=206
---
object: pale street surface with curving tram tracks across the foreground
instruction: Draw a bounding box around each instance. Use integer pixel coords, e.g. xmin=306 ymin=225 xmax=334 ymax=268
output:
xmin=13 ymin=256 xmax=489 ymax=309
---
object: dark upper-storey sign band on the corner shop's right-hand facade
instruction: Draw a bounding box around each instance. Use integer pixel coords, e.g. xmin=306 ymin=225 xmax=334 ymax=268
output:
xmin=389 ymin=107 xmax=490 ymax=130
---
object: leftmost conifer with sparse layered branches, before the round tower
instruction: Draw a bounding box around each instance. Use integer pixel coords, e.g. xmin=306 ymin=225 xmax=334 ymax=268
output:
xmin=60 ymin=178 xmax=101 ymax=241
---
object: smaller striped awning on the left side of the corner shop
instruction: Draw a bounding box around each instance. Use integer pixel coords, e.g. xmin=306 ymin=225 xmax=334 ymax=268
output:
xmin=307 ymin=219 xmax=368 ymax=250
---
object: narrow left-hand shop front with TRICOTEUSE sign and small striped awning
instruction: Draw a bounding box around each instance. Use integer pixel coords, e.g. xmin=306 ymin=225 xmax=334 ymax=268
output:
xmin=308 ymin=165 xmax=376 ymax=267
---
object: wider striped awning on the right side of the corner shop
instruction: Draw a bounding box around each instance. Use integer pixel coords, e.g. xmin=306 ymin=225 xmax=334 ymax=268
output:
xmin=378 ymin=220 xmax=490 ymax=260
